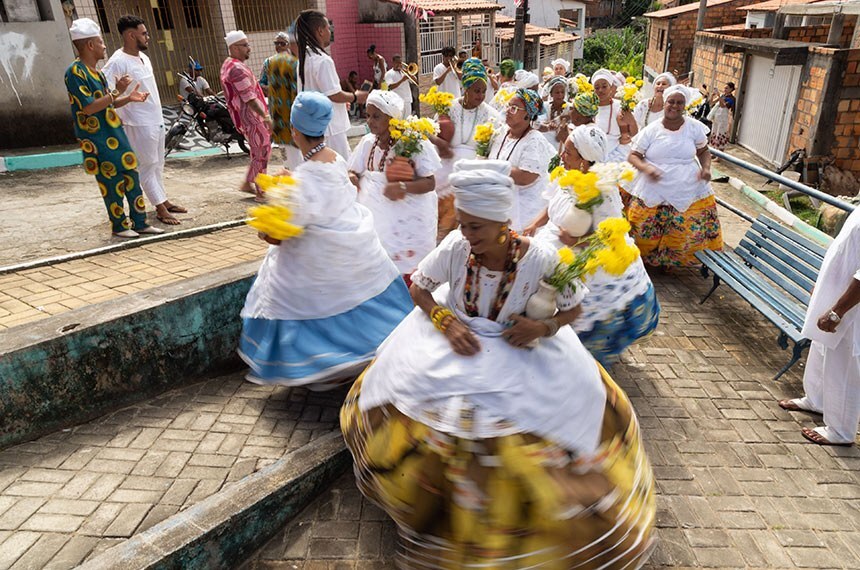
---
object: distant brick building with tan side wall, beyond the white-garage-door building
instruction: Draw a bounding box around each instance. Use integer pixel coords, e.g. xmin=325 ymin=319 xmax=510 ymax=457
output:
xmin=644 ymin=0 xmax=754 ymax=79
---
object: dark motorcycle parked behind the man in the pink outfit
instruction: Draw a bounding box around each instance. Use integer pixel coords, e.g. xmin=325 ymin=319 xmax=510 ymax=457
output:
xmin=164 ymin=73 xmax=250 ymax=158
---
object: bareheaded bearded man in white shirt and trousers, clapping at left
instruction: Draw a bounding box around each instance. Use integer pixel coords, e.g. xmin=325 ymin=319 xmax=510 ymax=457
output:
xmin=102 ymin=16 xmax=187 ymax=226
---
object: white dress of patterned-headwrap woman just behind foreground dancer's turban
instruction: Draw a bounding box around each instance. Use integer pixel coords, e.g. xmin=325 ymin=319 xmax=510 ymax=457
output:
xmin=489 ymin=126 xmax=555 ymax=232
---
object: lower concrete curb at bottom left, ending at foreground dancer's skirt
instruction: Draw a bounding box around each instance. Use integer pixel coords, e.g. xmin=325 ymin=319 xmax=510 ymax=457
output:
xmin=78 ymin=433 xmax=351 ymax=570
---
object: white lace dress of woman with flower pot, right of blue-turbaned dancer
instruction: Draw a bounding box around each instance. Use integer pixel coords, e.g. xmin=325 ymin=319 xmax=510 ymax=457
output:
xmin=349 ymin=134 xmax=441 ymax=275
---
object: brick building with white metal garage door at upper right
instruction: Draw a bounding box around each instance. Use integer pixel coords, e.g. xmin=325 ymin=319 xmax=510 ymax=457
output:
xmin=693 ymin=3 xmax=860 ymax=179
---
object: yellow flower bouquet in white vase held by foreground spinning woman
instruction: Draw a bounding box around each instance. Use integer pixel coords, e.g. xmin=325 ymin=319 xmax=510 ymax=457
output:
xmin=546 ymin=218 xmax=639 ymax=291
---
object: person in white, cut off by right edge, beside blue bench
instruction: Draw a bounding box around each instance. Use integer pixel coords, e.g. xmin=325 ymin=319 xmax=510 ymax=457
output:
xmin=779 ymin=208 xmax=860 ymax=445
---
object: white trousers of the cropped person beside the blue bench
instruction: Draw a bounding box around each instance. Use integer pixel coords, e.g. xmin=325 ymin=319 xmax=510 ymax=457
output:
xmin=801 ymin=334 xmax=860 ymax=443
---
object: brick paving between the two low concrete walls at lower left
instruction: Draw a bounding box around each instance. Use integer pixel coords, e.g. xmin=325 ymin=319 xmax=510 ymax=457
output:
xmin=0 ymin=374 xmax=345 ymax=570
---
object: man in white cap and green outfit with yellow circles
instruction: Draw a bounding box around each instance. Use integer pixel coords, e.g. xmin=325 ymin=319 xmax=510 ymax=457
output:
xmin=66 ymin=18 xmax=164 ymax=238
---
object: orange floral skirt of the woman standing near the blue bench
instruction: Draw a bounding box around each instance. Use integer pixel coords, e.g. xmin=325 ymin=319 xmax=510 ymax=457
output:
xmin=627 ymin=196 xmax=723 ymax=267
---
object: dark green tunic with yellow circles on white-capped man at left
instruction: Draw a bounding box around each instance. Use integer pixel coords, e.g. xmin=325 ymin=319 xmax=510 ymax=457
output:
xmin=66 ymin=59 xmax=137 ymax=178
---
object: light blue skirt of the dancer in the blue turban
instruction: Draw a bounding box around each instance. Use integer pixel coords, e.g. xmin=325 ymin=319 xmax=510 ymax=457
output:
xmin=239 ymin=277 xmax=414 ymax=390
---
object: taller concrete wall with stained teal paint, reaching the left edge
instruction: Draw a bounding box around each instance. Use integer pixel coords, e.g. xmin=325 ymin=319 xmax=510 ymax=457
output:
xmin=0 ymin=261 xmax=260 ymax=448
